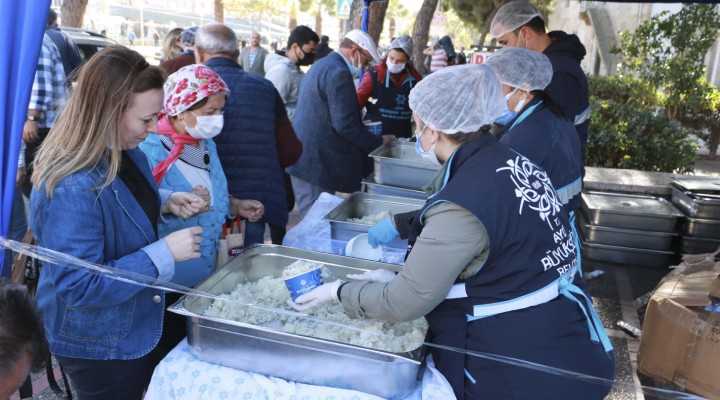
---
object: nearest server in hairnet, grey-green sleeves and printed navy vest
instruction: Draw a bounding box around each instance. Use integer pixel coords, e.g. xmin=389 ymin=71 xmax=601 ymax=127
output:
xmin=294 ymin=65 xmax=614 ymax=399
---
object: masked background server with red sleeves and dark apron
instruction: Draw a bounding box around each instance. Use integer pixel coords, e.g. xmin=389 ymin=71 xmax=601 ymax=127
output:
xmin=357 ymin=35 xmax=421 ymax=138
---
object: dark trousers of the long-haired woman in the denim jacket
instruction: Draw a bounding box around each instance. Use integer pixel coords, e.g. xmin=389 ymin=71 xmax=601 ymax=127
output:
xmin=55 ymin=293 xmax=186 ymax=400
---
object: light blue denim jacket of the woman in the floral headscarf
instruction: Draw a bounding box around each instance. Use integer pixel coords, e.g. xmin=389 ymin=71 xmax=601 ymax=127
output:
xmin=139 ymin=134 xmax=230 ymax=287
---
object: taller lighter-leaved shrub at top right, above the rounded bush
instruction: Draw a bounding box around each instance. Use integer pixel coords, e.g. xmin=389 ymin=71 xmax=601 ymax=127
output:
xmin=611 ymin=4 xmax=720 ymax=119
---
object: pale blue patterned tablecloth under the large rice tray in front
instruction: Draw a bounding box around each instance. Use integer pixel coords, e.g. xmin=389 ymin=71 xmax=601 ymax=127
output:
xmin=145 ymin=340 xmax=454 ymax=400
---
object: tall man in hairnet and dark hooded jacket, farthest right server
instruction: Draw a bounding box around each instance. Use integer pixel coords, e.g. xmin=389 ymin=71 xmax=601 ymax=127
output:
xmin=490 ymin=1 xmax=590 ymax=166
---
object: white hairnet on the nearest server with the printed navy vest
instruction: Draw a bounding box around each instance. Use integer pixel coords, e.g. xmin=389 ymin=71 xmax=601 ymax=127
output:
xmin=410 ymin=64 xmax=506 ymax=134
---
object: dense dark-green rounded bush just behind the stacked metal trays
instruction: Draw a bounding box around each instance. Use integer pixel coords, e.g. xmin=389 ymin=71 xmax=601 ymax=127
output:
xmin=585 ymin=76 xmax=697 ymax=173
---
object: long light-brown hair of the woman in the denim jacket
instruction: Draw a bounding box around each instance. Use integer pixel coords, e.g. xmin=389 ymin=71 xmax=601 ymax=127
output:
xmin=32 ymin=45 xmax=167 ymax=197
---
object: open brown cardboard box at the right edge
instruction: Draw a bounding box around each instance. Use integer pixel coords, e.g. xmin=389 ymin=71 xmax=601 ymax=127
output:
xmin=638 ymin=263 xmax=720 ymax=400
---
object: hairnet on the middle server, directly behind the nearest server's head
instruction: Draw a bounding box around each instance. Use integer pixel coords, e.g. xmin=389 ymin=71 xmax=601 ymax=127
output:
xmin=485 ymin=47 xmax=552 ymax=92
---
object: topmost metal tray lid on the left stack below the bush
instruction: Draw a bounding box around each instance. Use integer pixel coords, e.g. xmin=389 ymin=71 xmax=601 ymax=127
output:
xmin=582 ymin=192 xmax=683 ymax=217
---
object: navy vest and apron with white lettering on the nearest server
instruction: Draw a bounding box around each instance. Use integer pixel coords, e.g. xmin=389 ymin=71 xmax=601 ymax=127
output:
xmin=408 ymin=134 xmax=614 ymax=399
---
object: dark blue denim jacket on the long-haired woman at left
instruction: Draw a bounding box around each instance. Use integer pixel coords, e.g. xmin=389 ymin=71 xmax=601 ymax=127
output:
xmin=30 ymin=149 xmax=174 ymax=360
